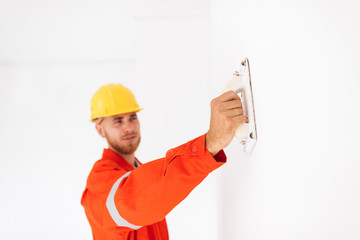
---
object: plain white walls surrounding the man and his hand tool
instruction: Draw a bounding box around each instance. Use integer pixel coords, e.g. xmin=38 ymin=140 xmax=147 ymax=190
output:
xmin=0 ymin=0 xmax=360 ymax=240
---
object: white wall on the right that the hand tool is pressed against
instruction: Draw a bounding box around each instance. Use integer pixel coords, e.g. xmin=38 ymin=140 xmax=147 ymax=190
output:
xmin=212 ymin=0 xmax=360 ymax=240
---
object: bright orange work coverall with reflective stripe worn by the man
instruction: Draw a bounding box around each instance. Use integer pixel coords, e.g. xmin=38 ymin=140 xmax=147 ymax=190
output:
xmin=81 ymin=135 xmax=226 ymax=240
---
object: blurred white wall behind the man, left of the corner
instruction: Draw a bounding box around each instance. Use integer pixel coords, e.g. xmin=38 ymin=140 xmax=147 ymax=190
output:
xmin=0 ymin=0 xmax=218 ymax=240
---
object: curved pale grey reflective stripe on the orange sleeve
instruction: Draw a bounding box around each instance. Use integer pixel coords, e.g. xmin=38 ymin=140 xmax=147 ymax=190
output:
xmin=106 ymin=172 xmax=142 ymax=230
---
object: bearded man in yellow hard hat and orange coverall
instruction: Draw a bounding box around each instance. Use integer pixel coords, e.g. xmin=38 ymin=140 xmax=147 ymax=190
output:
xmin=81 ymin=84 xmax=247 ymax=240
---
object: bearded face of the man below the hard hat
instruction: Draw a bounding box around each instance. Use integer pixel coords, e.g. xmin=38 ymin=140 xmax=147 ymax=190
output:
xmin=96 ymin=112 xmax=140 ymax=154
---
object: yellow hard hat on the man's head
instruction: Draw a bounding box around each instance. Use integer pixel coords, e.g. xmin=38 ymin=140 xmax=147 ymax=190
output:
xmin=91 ymin=83 xmax=143 ymax=121
